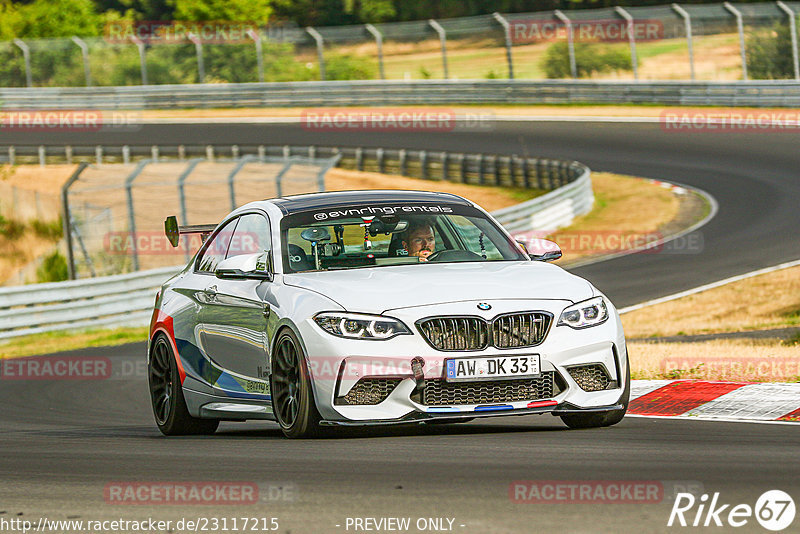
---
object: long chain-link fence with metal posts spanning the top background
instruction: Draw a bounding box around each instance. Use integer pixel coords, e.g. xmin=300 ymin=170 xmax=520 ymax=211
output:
xmin=0 ymin=2 xmax=800 ymax=87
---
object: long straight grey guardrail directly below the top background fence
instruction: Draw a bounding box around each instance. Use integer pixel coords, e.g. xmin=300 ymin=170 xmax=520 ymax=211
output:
xmin=0 ymin=80 xmax=800 ymax=110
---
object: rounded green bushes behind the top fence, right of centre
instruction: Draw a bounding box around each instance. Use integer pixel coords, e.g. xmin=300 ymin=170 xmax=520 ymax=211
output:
xmin=541 ymin=41 xmax=633 ymax=78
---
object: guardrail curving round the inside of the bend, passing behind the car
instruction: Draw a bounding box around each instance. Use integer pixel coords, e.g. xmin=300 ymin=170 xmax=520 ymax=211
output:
xmin=0 ymin=147 xmax=594 ymax=340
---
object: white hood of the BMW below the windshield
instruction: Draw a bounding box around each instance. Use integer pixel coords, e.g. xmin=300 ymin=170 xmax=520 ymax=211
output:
xmin=283 ymin=261 xmax=594 ymax=313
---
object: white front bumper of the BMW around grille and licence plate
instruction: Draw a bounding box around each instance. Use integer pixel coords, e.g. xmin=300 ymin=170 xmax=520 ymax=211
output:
xmin=299 ymin=300 xmax=629 ymax=425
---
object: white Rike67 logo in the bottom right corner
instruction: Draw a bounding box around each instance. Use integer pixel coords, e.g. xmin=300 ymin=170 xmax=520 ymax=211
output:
xmin=667 ymin=490 xmax=796 ymax=532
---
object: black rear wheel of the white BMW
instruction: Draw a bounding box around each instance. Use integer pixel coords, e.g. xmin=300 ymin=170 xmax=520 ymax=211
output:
xmin=147 ymin=334 xmax=219 ymax=436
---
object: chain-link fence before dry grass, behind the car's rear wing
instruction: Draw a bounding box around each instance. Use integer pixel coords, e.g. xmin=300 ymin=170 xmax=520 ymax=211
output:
xmin=62 ymin=155 xmax=337 ymax=278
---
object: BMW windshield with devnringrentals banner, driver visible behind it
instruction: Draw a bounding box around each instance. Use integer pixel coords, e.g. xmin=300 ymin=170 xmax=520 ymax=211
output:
xmin=281 ymin=203 xmax=527 ymax=273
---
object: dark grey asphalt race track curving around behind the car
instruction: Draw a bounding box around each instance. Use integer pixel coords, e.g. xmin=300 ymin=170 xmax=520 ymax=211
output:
xmin=0 ymin=122 xmax=800 ymax=533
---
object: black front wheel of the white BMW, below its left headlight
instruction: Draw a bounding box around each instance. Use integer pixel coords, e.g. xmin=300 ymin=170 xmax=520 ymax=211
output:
xmin=270 ymin=329 xmax=322 ymax=438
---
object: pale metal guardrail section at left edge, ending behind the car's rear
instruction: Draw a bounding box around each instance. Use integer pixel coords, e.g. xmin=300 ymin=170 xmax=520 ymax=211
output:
xmin=0 ymin=267 xmax=180 ymax=340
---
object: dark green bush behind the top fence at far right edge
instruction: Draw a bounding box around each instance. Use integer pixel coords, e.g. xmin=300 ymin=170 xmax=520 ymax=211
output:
xmin=746 ymin=24 xmax=794 ymax=80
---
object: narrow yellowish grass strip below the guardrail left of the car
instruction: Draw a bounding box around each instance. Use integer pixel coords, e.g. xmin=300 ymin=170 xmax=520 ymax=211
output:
xmin=0 ymin=327 xmax=148 ymax=359
